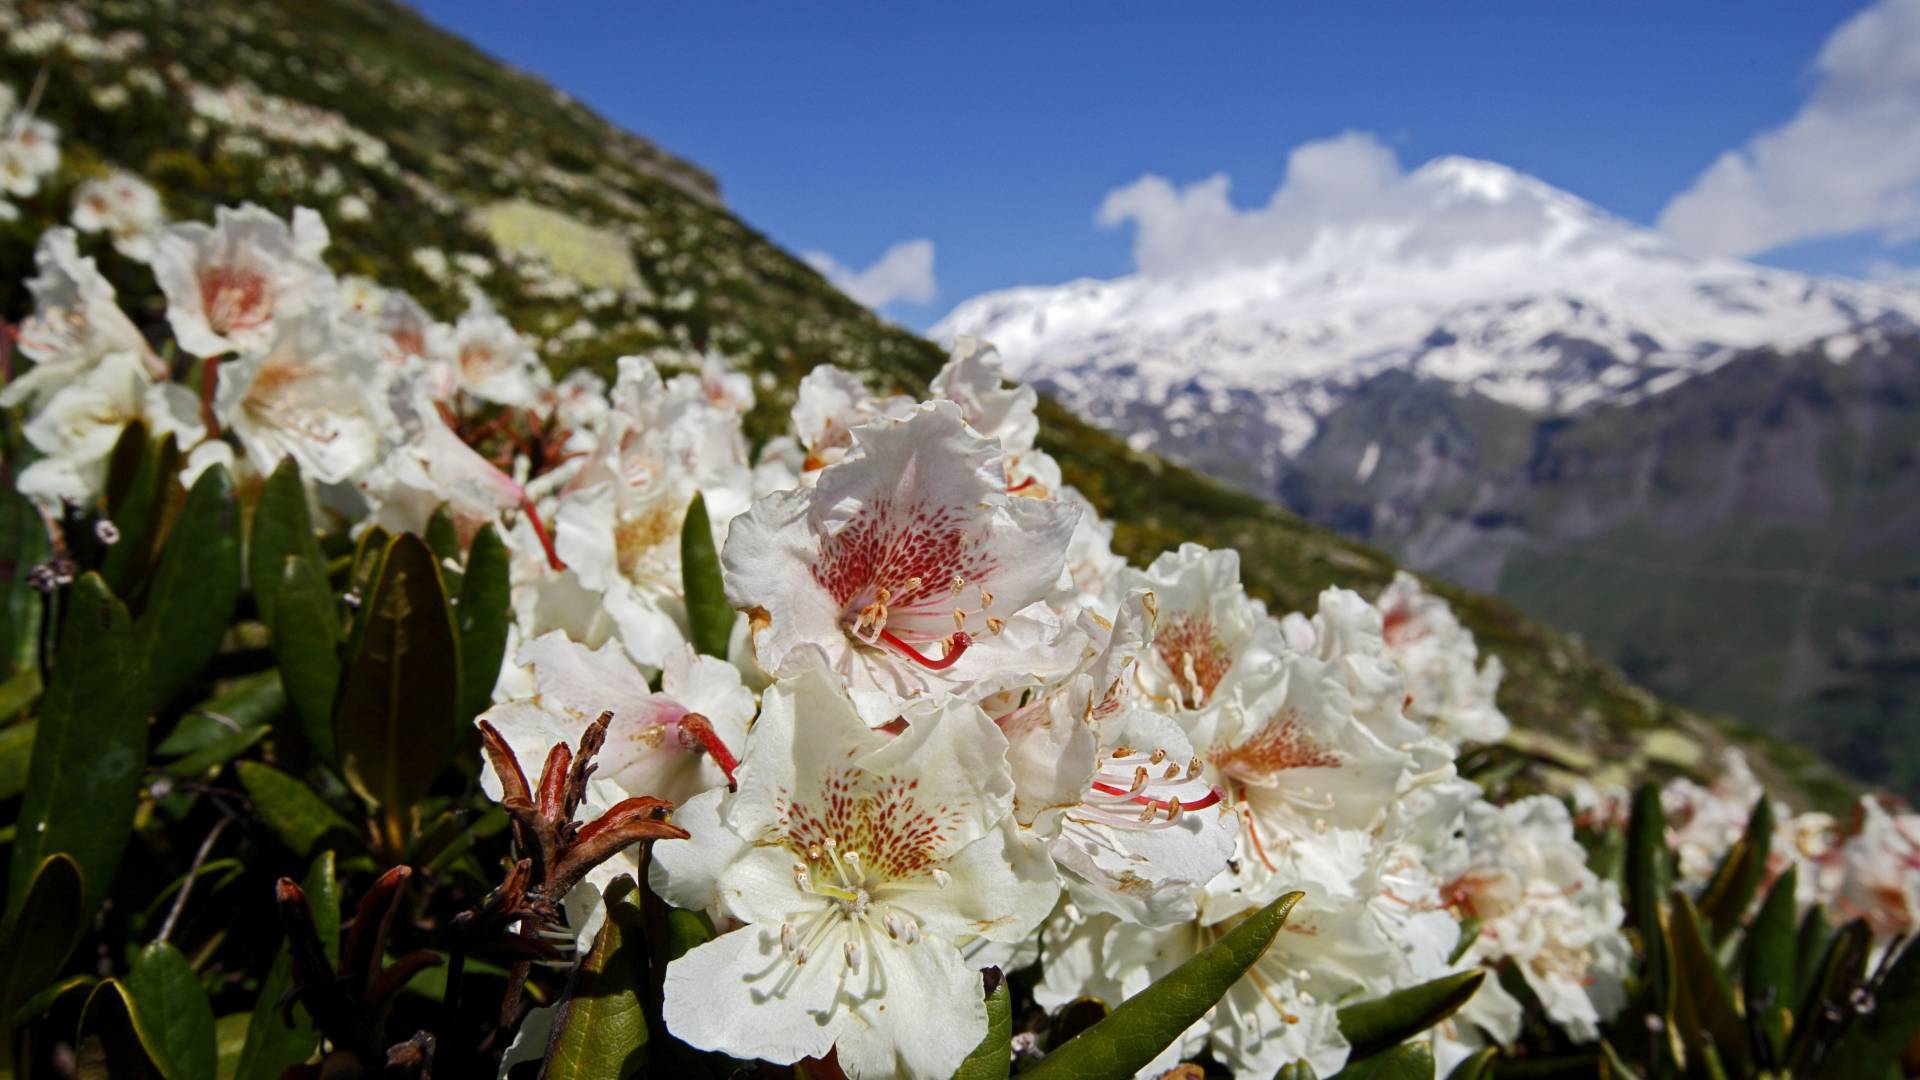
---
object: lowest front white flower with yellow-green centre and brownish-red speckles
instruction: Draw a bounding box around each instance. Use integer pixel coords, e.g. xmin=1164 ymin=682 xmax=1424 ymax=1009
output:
xmin=655 ymin=673 xmax=1060 ymax=1078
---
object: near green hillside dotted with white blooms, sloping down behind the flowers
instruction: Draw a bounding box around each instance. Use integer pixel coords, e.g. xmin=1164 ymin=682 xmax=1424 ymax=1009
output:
xmin=0 ymin=0 xmax=1847 ymax=803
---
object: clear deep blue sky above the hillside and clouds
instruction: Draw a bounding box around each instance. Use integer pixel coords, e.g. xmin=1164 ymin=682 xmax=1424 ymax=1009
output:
xmin=417 ymin=0 xmax=1920 ymax=327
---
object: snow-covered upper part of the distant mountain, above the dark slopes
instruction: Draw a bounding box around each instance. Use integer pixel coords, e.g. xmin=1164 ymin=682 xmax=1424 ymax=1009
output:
xmin=933 ymin=158 xmax=1920 ymax=463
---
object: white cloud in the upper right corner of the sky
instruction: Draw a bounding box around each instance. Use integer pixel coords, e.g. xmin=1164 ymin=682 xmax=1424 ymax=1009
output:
xmin=1661 ymin=0 xmax=1920 ymax=256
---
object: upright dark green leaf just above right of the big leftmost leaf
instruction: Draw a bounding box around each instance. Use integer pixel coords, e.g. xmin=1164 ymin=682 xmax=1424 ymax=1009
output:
xmin=134 ymin=465 xmax=240 ymax=711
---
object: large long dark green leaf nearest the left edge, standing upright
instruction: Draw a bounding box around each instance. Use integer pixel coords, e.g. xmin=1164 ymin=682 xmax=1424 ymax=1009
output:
xmin=8 ymin=575 xmax=146 ymax=922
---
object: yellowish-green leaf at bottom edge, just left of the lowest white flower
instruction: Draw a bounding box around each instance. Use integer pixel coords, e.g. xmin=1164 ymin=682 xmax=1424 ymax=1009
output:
xmin=541 ymin=878 xmax=647 ymax=1080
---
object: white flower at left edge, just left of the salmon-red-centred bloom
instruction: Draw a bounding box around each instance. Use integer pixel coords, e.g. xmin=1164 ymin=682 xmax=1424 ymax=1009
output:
xmin=0 ymin=229 xmax=165 ymax=405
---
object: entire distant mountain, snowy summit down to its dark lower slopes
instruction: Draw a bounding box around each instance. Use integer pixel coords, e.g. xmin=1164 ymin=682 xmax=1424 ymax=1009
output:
xmin=933 ymin=158 xmax=1920 ymax=792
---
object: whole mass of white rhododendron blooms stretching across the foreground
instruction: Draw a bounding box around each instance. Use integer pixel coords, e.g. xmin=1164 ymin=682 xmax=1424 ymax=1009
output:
xmin=0 ymin=184 xmax=1920 ymax=1078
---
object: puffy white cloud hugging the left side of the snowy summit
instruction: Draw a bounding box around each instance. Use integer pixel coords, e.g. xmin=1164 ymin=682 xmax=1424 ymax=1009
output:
xmin=1096 ymin=131 xmax=1605 ymax=277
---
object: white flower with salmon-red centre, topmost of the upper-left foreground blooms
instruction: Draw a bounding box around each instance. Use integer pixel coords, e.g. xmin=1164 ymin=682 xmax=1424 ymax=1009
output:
xmin=152 ymin=204 xmax=334 ymax=357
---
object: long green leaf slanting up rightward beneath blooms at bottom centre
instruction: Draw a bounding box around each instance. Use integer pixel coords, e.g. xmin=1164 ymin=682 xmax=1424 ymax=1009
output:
xmin=1021 ymin=892 xmax=1302 ymax=1080
